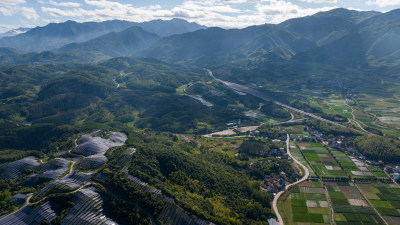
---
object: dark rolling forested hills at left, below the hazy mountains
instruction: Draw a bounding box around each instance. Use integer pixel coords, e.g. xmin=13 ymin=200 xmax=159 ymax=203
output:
xmin=0 ymin=58 xmax=241 ymax=150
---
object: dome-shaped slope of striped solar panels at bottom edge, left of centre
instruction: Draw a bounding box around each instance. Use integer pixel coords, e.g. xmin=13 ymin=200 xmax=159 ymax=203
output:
xmin=62 ymin=188 xmax=116 ymax=225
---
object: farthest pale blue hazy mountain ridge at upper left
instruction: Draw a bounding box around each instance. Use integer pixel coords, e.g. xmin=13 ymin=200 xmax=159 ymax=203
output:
xmin=0 ymin=19 xmax=204 ymax=52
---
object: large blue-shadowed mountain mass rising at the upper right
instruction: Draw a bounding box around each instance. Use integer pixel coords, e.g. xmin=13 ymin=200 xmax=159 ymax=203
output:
xmin=135 ymin=9 xmax=400 ymax=65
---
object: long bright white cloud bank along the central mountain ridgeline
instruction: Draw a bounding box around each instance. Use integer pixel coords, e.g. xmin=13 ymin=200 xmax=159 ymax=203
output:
xmin=37 ymin=0 xmax=335 ymax=28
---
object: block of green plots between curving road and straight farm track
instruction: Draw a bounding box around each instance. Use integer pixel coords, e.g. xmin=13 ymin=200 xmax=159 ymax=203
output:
xmin=278 ymin=181 xmax=330 ymax=224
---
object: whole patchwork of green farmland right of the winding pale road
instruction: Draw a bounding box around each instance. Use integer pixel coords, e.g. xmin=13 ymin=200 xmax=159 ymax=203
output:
xmin=278 ymin=136 xmax=400 ymax=225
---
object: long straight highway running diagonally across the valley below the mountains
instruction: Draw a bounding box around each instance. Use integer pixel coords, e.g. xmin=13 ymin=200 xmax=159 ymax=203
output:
xmin=207 ymin=70 xmax=343 ymax=126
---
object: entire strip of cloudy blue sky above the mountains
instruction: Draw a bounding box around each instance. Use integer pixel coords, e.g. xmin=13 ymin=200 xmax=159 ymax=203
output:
xmin=0 ymin=0 xmax=400 ymax=32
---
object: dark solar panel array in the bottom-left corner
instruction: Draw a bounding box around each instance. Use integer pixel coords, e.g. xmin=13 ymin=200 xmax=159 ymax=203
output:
xmin=0 ymin=202 xmax=57 ymax=225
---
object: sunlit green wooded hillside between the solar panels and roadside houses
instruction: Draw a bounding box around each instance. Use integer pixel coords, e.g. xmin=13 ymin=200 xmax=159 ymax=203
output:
xmin=129 ymin=138 xmax=276 ymax=224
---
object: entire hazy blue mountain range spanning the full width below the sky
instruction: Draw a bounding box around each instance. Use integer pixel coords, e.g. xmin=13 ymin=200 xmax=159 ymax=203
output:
xmin=0 ymin=8 xmax=400 ymax=66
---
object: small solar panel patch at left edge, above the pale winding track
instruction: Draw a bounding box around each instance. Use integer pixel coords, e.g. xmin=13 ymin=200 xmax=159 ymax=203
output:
xmin=3 ymin=157 xmax=40 ymax=180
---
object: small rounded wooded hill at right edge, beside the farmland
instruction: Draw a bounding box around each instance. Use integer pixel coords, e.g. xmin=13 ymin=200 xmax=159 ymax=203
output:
xmin=355 ymin=135 xmax=400 ymax=163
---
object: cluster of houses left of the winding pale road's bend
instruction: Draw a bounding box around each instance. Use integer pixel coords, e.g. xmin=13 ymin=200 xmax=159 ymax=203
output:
xmin=262 ymin=171 xmax=298 ymax=193
